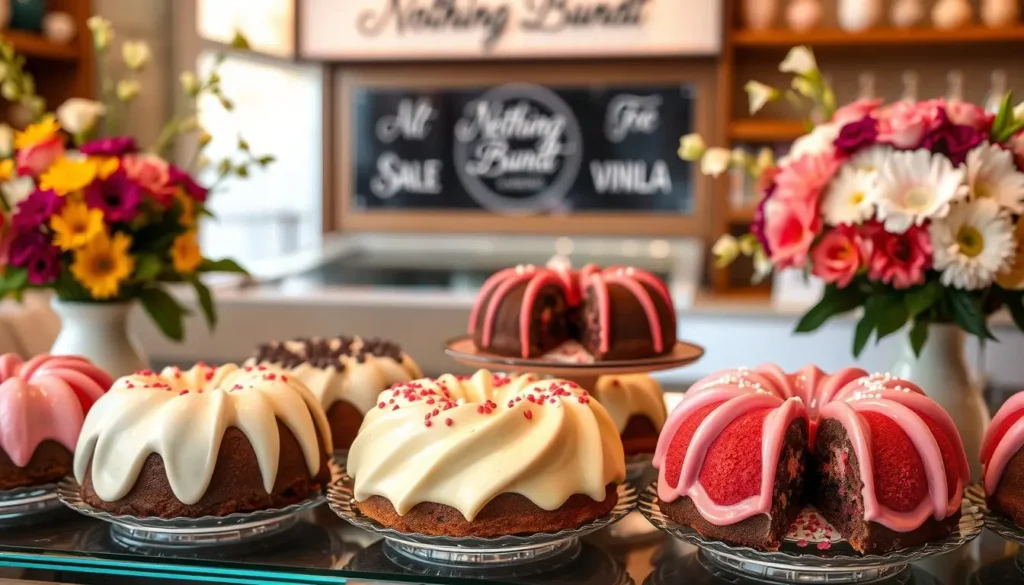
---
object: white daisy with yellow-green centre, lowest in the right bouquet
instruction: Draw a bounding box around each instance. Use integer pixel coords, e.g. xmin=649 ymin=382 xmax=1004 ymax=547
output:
xmin=929 ymin=199 xmax=1017 ymax=290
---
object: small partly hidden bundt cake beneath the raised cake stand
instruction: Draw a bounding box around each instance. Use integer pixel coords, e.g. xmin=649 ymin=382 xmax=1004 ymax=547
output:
xmin=591 ymin=374 xmax=668 ymax=456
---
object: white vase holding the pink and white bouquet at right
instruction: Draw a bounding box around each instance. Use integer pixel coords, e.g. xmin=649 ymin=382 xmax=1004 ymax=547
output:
xmin=892 ymin=325 xmax=990 ymax=482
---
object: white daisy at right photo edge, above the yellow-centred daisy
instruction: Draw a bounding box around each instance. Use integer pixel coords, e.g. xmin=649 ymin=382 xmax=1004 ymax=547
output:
xmin=964 ymin=143 xmax=1024 ymax=214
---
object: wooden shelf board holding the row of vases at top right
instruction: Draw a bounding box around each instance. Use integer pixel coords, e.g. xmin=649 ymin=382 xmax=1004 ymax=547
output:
xmin=732 ymin=26 xmax=1024 ymax=48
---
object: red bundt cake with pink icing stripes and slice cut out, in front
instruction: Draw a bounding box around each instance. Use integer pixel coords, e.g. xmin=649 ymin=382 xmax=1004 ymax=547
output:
xmin=654 ymin=365 xmax=970 ymax=553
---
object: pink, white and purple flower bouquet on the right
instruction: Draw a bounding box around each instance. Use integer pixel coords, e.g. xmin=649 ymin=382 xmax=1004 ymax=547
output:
xmin=680 ymin=47 xmax=1024 ymax=356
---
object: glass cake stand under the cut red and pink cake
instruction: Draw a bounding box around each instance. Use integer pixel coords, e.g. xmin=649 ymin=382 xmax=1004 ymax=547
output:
xmin=639 ymin=485 xmax=985 ymax=583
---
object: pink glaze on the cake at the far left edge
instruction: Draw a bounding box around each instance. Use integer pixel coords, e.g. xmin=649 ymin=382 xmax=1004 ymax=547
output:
xmin=0 ymin=353 xmax=114 ymax=467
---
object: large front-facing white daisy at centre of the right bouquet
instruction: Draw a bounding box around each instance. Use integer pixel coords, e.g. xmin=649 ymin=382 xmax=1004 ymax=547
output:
xmin=876 ymin=149 xmax=964 ymax=234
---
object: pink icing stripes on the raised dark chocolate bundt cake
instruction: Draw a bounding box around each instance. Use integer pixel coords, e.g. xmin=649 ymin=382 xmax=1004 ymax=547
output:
xmin=469 ymin=264 xmax=675 ymax=358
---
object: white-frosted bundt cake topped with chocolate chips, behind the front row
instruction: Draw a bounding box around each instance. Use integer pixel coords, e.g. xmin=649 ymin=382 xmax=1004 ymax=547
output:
xmin=247 ymin=336 xmax=423 ymax=451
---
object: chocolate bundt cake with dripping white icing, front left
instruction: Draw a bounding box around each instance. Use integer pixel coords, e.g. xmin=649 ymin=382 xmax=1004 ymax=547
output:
xmin=75 ymin=364 xmax=331 ymax=517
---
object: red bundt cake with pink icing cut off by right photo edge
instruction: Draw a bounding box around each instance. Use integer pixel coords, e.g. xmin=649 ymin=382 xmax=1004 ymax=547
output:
xmin=981 ymin=392 xmax=1024 ymax=527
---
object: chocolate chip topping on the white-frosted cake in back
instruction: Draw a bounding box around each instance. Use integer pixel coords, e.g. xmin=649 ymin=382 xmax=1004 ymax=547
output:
xmin=253 ymin=336 xmax=403 ymax=370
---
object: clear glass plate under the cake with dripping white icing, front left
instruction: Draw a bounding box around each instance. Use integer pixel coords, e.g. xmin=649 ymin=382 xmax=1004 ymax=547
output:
xmin=56 ymin=475 xmax=326 ymax=550
